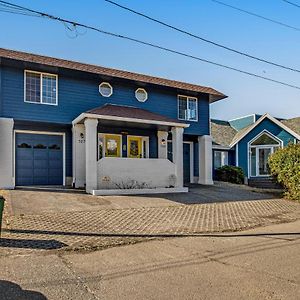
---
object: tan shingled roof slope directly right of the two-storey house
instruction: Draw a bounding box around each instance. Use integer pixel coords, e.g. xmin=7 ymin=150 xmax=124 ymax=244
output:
xmin=210 ymin=120 xmax=237 ymax=147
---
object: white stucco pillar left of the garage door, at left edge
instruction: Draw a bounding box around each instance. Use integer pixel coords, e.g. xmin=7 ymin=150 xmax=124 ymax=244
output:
xmin=0 ymin=118 xmax=15 ymax=189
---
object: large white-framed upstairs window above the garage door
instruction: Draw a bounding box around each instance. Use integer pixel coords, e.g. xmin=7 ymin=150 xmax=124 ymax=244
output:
xmin=24 ymin=70 xmax=58 ymax=105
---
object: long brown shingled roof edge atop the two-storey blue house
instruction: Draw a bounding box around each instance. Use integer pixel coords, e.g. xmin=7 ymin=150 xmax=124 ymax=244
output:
xmin=0 ymin=48 xmax=227 ymax=102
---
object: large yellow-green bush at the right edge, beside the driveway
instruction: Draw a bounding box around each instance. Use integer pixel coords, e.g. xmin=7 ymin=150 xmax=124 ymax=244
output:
xmin=268 ymin=144 xmax=300 ymax=200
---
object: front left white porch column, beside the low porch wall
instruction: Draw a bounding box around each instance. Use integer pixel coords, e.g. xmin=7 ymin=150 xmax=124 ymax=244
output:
xmin=84 ymin=119 xmax=98 ymax=193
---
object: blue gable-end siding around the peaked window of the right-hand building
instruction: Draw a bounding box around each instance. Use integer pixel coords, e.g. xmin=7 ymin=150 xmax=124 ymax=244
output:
xmin=238 ymin=119 xmax=294 ymax=177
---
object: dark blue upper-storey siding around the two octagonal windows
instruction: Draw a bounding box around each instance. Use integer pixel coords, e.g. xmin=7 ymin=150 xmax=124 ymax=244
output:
xmin=2 ymin=66 xmax=209 ymax=135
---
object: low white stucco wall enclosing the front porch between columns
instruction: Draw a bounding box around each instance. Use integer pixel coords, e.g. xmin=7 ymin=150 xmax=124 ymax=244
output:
xmin=97 ymin=157 xmax=176 ymax=189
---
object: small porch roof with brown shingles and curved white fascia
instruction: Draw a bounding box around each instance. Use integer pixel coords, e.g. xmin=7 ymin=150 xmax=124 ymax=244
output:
xmin=73 ymin=104 xmax=190 ymax=128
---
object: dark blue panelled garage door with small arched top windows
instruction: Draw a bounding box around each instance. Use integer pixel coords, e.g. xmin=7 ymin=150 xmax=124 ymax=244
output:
xmin=16 ymin=133 xmax=63 ymax=186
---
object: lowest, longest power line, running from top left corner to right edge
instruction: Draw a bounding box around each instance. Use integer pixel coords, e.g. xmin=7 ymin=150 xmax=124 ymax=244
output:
xmin=0 ymin=1 xmax=300 ymax=90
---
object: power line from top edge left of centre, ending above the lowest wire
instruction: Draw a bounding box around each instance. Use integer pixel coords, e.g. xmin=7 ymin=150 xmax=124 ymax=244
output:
xmin=104 ymin=0 xmax=300 ymax=73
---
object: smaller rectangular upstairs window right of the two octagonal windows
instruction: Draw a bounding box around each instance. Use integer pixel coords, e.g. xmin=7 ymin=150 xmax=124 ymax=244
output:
xmin=178 ymin=95 xmax=198 ymax=121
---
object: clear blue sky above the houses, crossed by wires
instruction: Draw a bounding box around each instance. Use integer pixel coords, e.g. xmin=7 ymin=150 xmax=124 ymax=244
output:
xmin=0 ymin=0 xmax=300 ymax=120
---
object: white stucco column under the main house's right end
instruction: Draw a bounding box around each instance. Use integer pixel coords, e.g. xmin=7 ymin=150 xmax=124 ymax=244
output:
xmin=198 ymin=135 xmax=214 ymax=185
